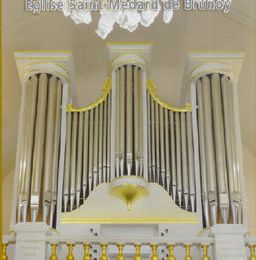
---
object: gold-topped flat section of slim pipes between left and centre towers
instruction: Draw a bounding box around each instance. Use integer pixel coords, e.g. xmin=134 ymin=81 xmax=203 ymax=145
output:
xmin=63 ymin=79 xmax=111 ymax=212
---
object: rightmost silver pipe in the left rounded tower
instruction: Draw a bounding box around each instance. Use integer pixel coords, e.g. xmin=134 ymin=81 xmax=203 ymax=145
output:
xmin=50 ymin=80 xmax=62 ymax=226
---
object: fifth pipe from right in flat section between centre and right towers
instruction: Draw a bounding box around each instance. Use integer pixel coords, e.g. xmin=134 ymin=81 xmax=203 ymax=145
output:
xmin=164 ymin=109 xmax=172 ymax=194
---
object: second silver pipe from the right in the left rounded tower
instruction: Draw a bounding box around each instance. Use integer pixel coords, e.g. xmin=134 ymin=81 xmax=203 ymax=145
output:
xmin=43 ymin=76 xmax=57 ymax=222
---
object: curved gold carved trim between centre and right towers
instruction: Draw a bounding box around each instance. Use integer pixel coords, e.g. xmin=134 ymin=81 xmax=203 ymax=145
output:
xmin=147 ymin=79 xmax=192 ymax=112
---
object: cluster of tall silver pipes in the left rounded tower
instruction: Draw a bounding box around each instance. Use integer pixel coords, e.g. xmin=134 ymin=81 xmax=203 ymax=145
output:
xmin=17 ymin=73 xmax=62 ymax=224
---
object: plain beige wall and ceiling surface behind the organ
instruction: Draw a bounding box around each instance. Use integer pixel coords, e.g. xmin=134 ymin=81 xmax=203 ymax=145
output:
xmin=2 ymin=0 xmax=256 ymax=177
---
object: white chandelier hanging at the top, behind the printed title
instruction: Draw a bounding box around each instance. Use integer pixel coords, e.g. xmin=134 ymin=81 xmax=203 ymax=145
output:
xmin=60 ymin=0 xmax=173 ymax=39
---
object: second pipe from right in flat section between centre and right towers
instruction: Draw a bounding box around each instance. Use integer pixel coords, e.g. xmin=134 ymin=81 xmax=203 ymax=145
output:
xmin=180 ymin=112 xmax=189 ymax=210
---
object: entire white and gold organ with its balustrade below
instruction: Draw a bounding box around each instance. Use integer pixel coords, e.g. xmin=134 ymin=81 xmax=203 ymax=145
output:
xmin=2 ymin=43 xmax=255 ymax=260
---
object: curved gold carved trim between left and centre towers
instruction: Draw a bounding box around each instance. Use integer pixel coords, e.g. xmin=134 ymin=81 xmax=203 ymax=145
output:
xmin=67 ymin=77 xmax=112 ymax=112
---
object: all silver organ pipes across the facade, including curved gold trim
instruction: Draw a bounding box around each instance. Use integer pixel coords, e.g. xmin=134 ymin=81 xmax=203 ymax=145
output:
xmin=15 ymin=45 xmax=243 ymax=237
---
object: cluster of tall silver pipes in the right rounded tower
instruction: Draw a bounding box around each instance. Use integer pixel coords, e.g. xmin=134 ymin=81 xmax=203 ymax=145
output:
xmin=196 ymin=74 xmax=242 ymax=226
